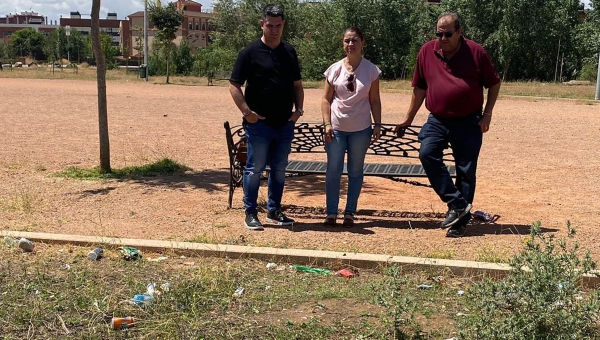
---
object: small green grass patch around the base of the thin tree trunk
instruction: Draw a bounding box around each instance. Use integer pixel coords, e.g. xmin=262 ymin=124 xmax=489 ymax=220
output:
xmin=54 ymin=158 xmax=192 ymax=179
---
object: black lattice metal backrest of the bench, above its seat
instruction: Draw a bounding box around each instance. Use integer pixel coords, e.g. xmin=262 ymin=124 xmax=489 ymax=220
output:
xmin=225 ymin=122 xmax=452 ymax=164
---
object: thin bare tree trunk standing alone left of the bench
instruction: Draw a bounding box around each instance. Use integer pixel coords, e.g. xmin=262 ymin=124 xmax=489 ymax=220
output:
xmin=92 ymin=0 xmax=111 ymax=173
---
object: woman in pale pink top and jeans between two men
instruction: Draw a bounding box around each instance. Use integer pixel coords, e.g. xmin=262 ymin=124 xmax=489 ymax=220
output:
xmin=321 ymin=27 xmax=381 ymax=227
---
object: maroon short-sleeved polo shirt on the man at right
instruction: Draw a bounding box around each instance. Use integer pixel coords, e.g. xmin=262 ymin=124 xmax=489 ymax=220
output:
xmin=412 ymin=37 xmax=500 ymax=118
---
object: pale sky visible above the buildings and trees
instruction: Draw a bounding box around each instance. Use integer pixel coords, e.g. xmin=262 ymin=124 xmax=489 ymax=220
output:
xmin=0 ymin=0 xmax=589 ymax=20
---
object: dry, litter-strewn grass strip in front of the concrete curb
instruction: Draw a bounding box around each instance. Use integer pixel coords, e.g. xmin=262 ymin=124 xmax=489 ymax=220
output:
xmin=0 ymin=244 xmax=474 ymax=339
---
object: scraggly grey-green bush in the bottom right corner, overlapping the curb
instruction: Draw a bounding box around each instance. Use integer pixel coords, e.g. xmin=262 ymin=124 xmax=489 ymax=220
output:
xmin=458 ymin=222 xmax=600 ymax=340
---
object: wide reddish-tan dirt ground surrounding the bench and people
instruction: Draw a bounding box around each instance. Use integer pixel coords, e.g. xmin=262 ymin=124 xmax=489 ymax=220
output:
xmin=0 ymin=79 xmax=600 ymax=260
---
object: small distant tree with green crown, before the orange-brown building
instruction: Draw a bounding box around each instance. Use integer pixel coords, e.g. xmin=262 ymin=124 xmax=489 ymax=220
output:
xmin=148 ymin=0 xmax=183 ymax=84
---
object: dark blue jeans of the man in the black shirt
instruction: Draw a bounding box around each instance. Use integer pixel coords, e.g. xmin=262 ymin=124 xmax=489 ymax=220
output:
xmin=243 ymin=121 xmax=294 ymax=214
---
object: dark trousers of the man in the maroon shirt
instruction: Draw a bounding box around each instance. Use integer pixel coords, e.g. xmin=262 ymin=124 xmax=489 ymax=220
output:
xmin=419 ymin=111 xmax=483 ymax=209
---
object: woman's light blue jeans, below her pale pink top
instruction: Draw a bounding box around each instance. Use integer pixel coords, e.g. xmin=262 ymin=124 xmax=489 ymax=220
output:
xmin=325 ymin=126 xmax=372 ymax=215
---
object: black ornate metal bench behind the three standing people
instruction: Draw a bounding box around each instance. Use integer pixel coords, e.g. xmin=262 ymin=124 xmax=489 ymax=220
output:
xmin=224 ymin=122 xmax=456 ymax=208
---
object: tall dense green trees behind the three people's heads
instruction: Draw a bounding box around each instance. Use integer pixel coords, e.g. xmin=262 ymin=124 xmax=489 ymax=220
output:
xmin=211 ymin=0 xmax=600 ymax=81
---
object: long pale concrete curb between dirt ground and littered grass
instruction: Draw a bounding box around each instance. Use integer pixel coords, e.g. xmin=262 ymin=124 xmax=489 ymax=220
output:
xmin=0 ymin=230 xmax=600 ymax=287
